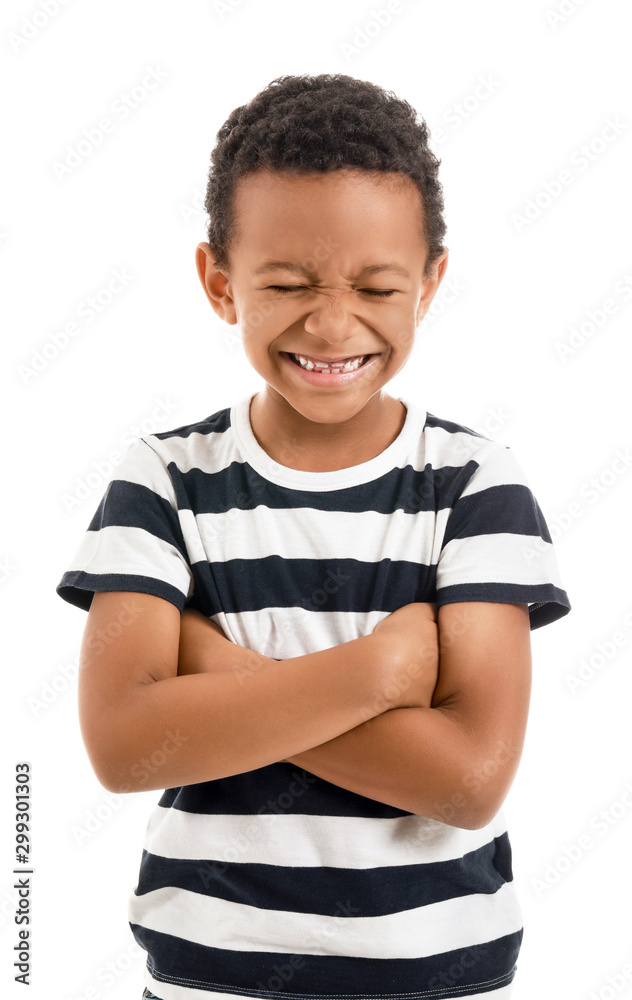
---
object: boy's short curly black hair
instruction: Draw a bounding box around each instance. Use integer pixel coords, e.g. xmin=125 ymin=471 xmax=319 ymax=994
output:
xmin=204 ymin=73 xmax=446 ymax=277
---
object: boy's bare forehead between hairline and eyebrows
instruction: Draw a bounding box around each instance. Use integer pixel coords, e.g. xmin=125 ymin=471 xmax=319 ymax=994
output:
xmin=234 ymin=168 xmax=423 ymax=256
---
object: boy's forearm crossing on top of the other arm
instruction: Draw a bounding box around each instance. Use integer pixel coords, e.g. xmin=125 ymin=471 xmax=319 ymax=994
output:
xmin=100 ymin=636 xmax=390 ymax=791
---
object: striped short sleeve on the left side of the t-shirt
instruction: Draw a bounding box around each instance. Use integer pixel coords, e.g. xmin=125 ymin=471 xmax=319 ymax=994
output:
xmin=56 ymin=438 xmax=193 ymax=611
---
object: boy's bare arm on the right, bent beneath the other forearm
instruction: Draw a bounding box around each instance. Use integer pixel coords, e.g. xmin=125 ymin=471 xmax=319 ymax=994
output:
xmin=175 ymin=601 xmax=531 ymax=829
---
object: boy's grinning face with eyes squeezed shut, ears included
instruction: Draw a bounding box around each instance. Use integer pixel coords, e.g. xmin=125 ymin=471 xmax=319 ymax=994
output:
xmin=196 ymin=169 xmax=448 ymax=423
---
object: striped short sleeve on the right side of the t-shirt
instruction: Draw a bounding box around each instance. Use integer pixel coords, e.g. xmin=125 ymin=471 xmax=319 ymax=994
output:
xmin=436 ymin=441 xmax=571 ymax=630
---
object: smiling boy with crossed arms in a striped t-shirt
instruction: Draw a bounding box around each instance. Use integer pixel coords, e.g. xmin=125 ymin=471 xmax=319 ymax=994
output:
xmin=57 ymin=74 xmax=570 ymax=1000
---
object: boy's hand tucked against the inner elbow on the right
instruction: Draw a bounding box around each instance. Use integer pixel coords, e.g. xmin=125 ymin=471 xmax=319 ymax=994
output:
xmin=373 ymin=602 xmax=439 ymax=708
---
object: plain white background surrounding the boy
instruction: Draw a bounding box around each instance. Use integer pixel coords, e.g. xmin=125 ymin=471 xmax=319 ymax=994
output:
xmin=0 ymin=0 xmax=632 ymax=1000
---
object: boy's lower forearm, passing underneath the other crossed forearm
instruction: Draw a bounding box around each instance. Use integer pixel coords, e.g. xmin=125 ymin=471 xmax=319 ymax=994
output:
xmin=286 ymin=708 xmax=491 ymax=829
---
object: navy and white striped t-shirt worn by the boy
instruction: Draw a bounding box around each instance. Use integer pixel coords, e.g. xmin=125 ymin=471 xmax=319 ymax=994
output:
xmin=57 ymin=396 xmax=570 ymax=1000
